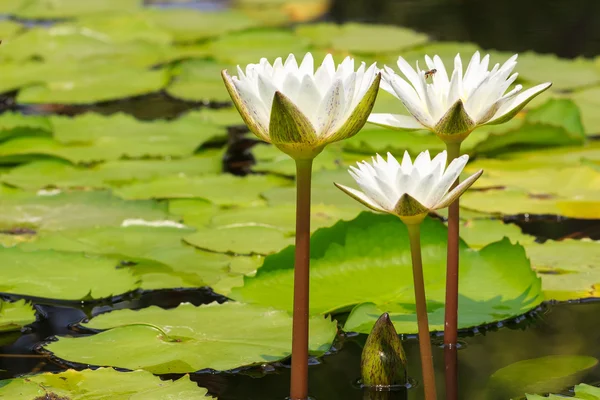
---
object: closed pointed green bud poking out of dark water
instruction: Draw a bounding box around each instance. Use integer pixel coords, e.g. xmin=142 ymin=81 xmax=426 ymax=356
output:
xmin=360 ymin=313 xmax=407 ymax=387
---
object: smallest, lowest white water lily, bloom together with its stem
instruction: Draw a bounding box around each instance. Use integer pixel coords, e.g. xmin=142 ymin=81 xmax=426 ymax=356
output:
xmin=335 ymin=151 xmax=483 ymax=400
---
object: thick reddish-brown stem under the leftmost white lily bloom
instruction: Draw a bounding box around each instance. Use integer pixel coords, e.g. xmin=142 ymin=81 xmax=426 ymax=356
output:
xmin=290 ymin=159 xmax=313 ymax=400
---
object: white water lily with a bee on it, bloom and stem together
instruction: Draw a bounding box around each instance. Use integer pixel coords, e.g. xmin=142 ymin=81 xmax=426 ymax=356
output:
xmin=369 ymin=52 xmax=552 ymax=400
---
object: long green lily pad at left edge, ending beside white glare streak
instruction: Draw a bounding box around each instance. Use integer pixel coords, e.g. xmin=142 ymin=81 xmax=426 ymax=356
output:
xmin=0 ymin=192 xmax=167 ymax=230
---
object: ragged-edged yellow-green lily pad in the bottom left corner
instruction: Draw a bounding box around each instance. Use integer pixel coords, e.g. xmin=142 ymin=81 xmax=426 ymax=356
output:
xmin=0 ymin=368 xmax=212 ymax=400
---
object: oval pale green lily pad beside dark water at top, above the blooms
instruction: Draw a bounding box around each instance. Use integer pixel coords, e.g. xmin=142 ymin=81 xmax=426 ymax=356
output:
xmin=296 ymin=23 xmax=427 ymax=54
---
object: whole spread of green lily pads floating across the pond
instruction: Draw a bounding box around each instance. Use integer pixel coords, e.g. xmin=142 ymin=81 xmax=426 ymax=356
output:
xmin=0 ymin=0 xmax=600 ymax=399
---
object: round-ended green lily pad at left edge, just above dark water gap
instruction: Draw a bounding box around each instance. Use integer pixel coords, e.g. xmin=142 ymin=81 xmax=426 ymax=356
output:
xmin=0 ymin=247 xmax=139 ymax=301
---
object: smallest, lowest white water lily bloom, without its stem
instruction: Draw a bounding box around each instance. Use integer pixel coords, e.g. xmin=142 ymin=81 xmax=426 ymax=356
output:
xmin=335 ymin=151 xmax=483 ymax=219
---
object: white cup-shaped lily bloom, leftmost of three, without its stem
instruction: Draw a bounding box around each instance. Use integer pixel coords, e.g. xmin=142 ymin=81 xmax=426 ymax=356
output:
xmin=222 ymin=53 xmax=381 ymax=159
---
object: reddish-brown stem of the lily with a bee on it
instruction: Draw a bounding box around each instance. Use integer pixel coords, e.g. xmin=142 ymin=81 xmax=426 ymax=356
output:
xmin=444 ymin=142 xmax=460 ymax=400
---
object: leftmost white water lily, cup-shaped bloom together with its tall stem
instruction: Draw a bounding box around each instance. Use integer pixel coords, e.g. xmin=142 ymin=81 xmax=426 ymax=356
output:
xmin=222 ymin=53 xmax=381 ymax=400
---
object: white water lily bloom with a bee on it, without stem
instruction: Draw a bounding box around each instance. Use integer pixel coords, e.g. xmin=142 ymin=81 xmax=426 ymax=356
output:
xmin=369 ymin=52 xmax=552 ymax=141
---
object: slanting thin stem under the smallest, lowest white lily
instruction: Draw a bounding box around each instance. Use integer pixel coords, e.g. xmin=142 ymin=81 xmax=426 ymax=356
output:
xmin=406 ymin=223 xmax=437 ymax=400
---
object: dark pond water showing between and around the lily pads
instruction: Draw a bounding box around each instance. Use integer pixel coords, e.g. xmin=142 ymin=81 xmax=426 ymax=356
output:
xmin=0 ymin=0 xmax=600 ymax=400
